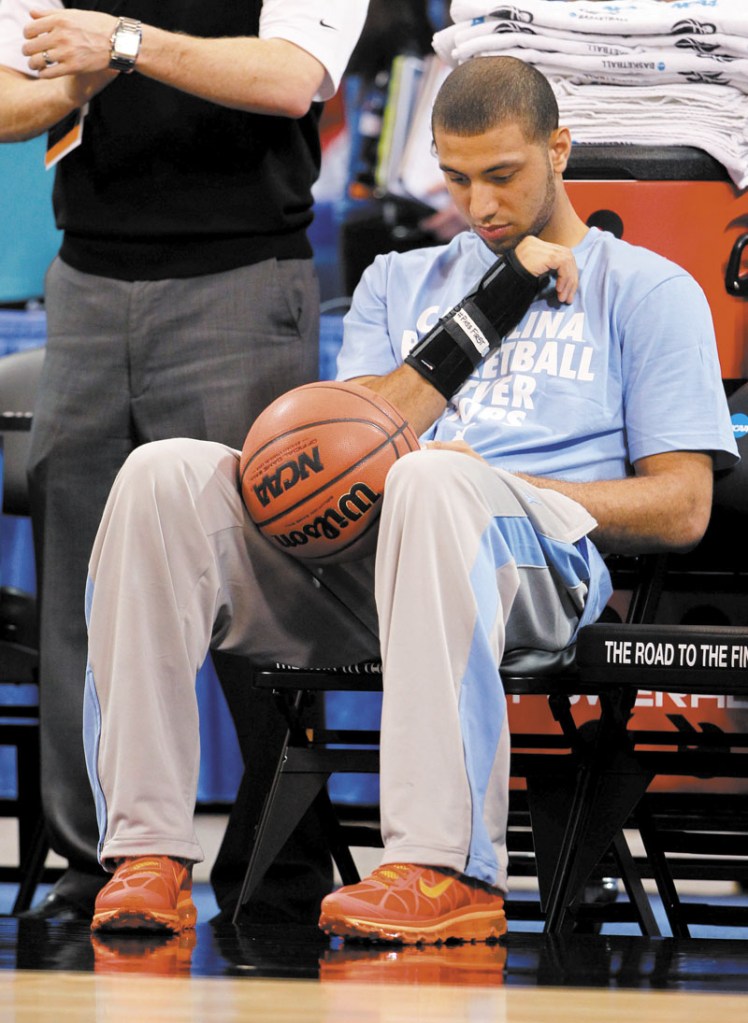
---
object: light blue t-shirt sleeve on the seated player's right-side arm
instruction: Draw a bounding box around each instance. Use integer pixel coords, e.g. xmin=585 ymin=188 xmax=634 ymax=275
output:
xmin=622 ymin=273 xmax=737 ymax=469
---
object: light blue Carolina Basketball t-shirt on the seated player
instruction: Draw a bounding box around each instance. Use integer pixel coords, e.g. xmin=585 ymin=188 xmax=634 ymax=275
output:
xmin=338 ymin=228 xmax=737 ymax=481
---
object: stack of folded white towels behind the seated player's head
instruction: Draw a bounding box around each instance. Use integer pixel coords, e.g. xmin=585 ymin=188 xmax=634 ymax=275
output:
xmin=434 ymin=0 xmax=748 ymax=189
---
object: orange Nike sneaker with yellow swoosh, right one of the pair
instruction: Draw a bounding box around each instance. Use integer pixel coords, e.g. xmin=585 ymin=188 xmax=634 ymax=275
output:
xmin=319 ymin=863 xmax=507 ymax=944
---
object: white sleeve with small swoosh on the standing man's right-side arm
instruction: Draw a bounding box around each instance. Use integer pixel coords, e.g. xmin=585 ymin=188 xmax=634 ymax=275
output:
xmin=260 ymin=0 xmax=368 ymax=100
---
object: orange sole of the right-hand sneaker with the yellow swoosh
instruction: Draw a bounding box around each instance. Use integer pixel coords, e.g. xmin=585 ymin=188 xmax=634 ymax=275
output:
xmin=319 ymin=909 xmax=507 ymax=945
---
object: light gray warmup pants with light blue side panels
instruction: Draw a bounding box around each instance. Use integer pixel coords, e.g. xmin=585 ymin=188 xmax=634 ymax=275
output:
xmin=84 ymin=440 xmax=606 ymax=887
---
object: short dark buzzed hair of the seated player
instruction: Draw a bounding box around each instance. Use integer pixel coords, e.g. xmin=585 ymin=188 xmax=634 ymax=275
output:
xmin=431 ymin=56 xmax=559 ymax=142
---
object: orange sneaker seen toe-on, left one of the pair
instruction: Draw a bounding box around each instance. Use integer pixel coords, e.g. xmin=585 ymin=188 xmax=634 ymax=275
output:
xmin=91 ymin=856 xmax=197 ymax=934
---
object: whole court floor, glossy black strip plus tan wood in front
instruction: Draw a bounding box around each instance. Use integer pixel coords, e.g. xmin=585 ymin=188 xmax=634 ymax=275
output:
xmin=0 ymin=896 xmax=748 ymax=1023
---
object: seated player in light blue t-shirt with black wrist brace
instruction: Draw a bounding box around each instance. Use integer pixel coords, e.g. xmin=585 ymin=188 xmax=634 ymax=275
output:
xmin=85 ymin=57 xmax=737 ymax=942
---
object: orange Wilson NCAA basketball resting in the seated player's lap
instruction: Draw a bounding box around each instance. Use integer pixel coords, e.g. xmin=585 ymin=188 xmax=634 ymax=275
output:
xmin=239 ymin=381 xmax=419 ymax=564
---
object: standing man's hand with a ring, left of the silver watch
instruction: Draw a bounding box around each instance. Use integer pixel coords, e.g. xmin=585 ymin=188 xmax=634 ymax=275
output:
xmin=24 ymin=10 xmax=118 ymax=77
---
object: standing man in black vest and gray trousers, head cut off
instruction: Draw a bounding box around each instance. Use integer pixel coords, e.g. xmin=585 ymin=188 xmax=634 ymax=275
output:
xmin=0 ymin=0 xmax=367 ymax=920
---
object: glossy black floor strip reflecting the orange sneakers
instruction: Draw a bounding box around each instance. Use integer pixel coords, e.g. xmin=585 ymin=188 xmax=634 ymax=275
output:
xmin=0 ymin=918 xmax=748 ymax=993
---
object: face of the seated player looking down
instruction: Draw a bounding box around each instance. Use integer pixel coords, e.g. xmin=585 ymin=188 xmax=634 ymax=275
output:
xmin=434 ymin=123 xmax=566 ymax=255
